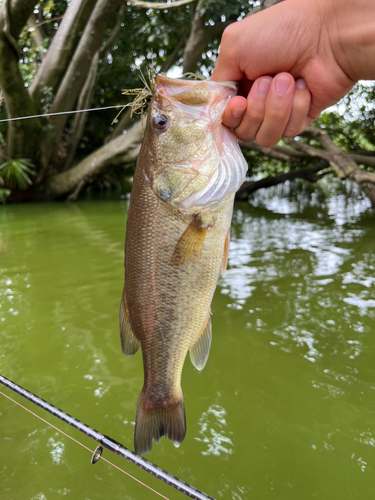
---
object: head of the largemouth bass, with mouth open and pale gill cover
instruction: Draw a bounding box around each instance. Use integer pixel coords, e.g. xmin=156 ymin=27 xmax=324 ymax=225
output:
xmin=145 ymin=75 xmax=247 ymax=211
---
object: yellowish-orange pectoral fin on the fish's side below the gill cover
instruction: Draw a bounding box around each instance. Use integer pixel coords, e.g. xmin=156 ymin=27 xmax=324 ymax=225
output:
xmin=172 ymin=217 xmax=208 ymax=265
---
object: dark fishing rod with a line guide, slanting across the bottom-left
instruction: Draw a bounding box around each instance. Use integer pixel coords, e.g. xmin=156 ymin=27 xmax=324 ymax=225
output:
xmin=0 ymin=375 xmax=214 ymax=500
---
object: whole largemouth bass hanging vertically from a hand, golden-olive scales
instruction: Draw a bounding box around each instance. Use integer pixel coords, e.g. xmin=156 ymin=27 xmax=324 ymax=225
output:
xmin=120 ymin=75 xmax=247 ymax=455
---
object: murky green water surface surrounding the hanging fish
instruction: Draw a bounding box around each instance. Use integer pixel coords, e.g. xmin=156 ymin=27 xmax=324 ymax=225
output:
xmin=0 ymin=190 xmax=375 ymax=500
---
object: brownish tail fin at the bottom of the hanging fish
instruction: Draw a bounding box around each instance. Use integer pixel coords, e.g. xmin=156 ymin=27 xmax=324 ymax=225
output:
xmin=134 ymin=391 xmax=186 ymax=455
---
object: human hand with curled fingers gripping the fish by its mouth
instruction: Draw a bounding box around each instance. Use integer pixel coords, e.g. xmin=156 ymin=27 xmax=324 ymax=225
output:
xmin=211 ymin=0 xmax=364 ymax=147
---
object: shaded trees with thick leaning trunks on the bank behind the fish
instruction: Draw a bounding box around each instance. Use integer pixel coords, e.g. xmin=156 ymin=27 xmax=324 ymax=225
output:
xmin=0 ymin=0 xmax=375 ymax=208
